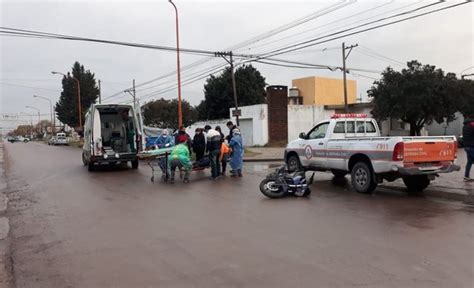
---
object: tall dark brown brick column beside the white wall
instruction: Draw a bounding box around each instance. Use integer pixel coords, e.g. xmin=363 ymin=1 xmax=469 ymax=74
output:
xmin=267 ymin=86 xmax=288 ymax=143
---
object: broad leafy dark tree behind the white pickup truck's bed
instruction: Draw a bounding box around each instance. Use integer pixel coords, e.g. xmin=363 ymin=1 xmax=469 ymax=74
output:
xmin=367 ymin=61 xmax=459 ymax=135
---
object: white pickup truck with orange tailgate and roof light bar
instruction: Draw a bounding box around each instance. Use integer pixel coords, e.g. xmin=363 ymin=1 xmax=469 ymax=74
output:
xmin=285 ymin=114 xmax=460 ymax=193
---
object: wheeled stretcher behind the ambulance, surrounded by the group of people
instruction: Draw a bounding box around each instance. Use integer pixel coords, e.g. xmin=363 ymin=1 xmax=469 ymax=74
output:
xmin=138 ymin=147 xmax=210 ymax=182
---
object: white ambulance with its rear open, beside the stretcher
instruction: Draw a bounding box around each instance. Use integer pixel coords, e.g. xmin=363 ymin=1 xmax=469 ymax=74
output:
xmin=82 ymin=104 xmax=143 ymax=171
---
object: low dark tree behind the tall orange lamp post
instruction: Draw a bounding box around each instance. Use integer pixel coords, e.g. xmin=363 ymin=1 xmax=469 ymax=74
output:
xmin=142 ymin=98 xmax=198 ymax=129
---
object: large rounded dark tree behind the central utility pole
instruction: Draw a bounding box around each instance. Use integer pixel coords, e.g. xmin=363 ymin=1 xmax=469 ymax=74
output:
xmin=196 ymin=65 xmax=266 ymax=120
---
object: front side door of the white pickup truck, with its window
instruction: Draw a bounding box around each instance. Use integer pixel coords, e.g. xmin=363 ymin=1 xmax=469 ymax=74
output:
xmin=305 ymin=122 xmax=329 ymax=168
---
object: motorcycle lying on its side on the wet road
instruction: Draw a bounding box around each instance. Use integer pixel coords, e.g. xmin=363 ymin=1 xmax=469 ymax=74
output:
xmin=260 ymin=166 xmax=314 ymax=199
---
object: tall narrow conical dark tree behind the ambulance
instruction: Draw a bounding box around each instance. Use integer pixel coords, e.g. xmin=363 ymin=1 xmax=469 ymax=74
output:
xmin=56 ymin=61 xmax=99 ymax=127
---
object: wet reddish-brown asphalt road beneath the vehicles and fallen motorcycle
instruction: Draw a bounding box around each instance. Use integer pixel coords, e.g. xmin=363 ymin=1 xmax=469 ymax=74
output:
xmin=5 ymin=143 xmax=474 ymax=287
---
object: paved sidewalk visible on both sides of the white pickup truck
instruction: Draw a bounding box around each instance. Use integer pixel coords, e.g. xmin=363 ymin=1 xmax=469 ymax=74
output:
xmin=244 ymin=147 xmax=474 ymax=203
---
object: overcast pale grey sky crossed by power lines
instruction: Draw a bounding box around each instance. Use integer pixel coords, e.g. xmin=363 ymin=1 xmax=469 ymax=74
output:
xmin=0 ymin=0 xmax=474 ymax=132
